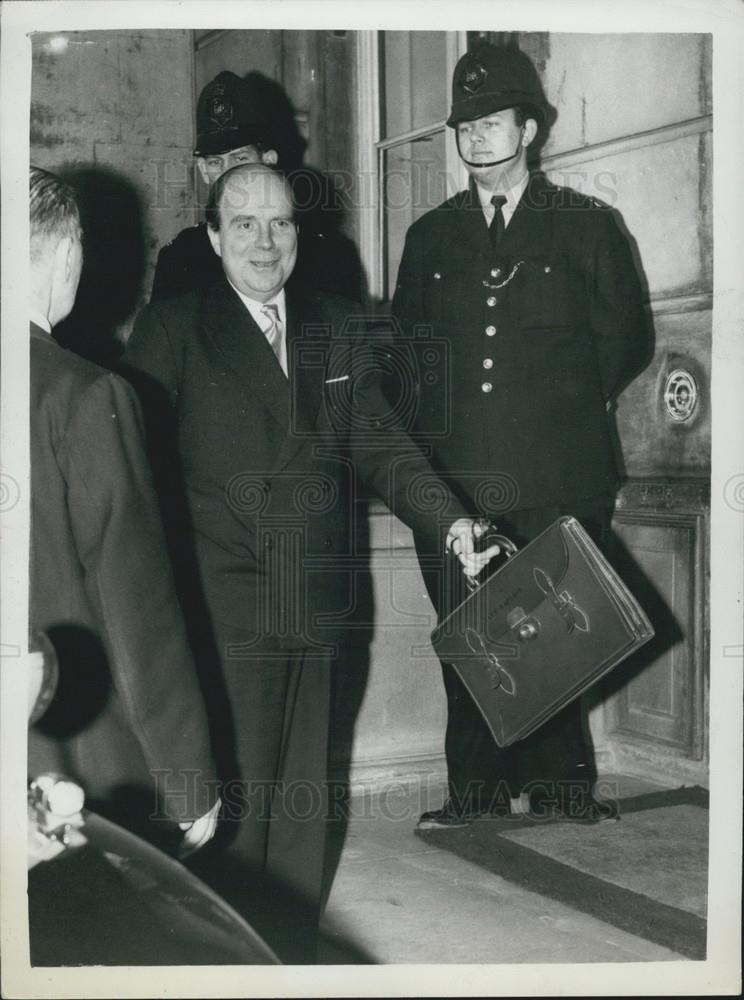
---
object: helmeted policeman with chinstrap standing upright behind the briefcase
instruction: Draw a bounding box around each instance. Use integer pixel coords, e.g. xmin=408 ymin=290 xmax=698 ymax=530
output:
xmin=392 ymin=44 xmax=647 ymax=828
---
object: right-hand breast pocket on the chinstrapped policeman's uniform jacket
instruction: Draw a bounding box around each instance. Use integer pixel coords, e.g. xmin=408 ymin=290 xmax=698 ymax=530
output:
xmin=511 ymin=253 xmax=586 ymax=333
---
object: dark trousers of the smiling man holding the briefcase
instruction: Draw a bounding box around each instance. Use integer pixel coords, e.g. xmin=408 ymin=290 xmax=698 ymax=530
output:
xmin=192 ymin=625 xmax=331 ymax=964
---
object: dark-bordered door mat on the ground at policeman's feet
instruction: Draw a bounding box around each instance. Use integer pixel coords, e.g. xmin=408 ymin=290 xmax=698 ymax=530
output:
xmin=418 ymin=788 xmax=708 ymax=960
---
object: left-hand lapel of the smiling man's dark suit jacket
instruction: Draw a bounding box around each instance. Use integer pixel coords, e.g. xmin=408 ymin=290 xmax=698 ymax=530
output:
xmin=204 ymin=277 xmax=290 ymax=429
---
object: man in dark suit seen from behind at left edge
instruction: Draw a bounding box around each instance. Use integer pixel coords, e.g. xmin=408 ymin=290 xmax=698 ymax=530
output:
xmin=29 ymin=167 xmax=219 ymax=853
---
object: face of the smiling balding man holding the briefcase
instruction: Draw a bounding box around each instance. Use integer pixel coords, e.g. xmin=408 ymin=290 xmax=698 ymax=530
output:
xmin=207 ymin=166 xmax=297 ymax=302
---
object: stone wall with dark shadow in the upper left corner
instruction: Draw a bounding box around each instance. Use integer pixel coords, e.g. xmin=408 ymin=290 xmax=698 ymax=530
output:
xmin=31 ymin=30 xmax=197 ymax=360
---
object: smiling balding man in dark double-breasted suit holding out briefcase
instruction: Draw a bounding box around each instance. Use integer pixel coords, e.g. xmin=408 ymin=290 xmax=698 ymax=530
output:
xmin=124 ymin=164 xmax=491 ymax=961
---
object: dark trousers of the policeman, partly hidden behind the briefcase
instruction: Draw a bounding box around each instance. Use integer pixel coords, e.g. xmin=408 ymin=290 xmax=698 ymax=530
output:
xmin=422 ymin=498 xmax=611 ymax=811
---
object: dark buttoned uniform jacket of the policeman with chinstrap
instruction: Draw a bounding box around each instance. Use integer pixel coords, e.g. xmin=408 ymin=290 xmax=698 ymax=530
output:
xmin=393 ymin=174 xmax=645 ymax=514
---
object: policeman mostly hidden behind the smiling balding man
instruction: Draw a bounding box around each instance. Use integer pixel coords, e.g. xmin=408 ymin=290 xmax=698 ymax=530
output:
xmin=151 ymin=70 xmax=362 ymax=301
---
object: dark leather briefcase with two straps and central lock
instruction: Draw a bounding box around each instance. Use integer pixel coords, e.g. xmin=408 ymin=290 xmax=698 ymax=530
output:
xmin=432 ymin=517 xmax=654 ymax=747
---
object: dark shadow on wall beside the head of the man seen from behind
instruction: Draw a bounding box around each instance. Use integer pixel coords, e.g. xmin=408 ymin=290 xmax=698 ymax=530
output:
xmin=54 ymin=167 xmax=145 ymax=368
